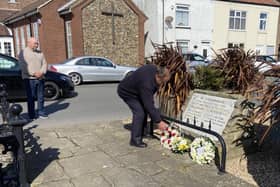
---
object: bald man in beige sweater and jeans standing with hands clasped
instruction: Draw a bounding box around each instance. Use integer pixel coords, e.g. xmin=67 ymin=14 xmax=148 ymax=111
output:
xmin=19 ymin=37 xmax=48 ymax=120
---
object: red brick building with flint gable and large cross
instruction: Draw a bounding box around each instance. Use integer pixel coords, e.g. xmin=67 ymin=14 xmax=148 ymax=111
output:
xmin=5 ymin=0 xmax=147 ymax=65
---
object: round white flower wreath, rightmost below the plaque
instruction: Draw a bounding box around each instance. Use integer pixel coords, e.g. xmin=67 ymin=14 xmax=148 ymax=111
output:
xmin=190 ymin=137 xmax=216 ymax=165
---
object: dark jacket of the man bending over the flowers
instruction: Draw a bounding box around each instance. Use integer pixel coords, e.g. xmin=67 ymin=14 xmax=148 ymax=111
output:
xmin=118 ymin=64 xmax=161 ymax=123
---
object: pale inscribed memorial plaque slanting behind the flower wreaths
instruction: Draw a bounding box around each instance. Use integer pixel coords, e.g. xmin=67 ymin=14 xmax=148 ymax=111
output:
xmin=182 ymin=93 xmax=236 ymax=139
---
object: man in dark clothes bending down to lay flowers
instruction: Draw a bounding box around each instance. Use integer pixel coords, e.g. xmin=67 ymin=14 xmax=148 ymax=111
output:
xmin=118 ymin=64 xmax=170 ymax=148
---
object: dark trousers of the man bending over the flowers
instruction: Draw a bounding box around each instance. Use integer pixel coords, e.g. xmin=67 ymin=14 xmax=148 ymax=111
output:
xmin=122 ymin=98 xmax=147 ymax=143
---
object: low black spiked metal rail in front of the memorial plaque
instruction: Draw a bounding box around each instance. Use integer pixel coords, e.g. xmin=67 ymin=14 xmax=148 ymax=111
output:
xmin=149 ymin=115 xmax=227 ymax=174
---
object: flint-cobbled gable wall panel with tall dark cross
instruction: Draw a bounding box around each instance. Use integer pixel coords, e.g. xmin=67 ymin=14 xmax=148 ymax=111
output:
xmin=82 ymin=0 xmax=139 ymax=66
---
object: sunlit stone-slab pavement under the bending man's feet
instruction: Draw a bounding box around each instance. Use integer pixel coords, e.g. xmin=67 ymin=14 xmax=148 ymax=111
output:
xmin=24 ymin=121 xmax=252 ymax=187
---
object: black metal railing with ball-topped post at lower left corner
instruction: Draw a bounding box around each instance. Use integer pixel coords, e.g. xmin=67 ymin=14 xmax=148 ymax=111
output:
xmin=0 ymin=84 xmax=30 ymax=187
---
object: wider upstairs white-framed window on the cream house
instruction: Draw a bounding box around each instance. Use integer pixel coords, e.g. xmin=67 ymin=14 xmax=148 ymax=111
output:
xmin=228 ymin=9 xmax=247 ymax=31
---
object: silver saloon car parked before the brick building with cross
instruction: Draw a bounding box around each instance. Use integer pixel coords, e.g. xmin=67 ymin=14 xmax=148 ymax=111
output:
xmin=49 ymin=56 xmax=136 ymax=85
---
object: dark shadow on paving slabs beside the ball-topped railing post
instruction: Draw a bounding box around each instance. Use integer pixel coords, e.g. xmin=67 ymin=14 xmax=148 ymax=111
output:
xmin=24 ymin=125 xmax=60 ymax=183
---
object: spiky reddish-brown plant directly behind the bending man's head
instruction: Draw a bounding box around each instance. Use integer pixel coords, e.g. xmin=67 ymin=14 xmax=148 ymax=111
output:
xmin=151 ymin=43 xmax=191 ymax=117
